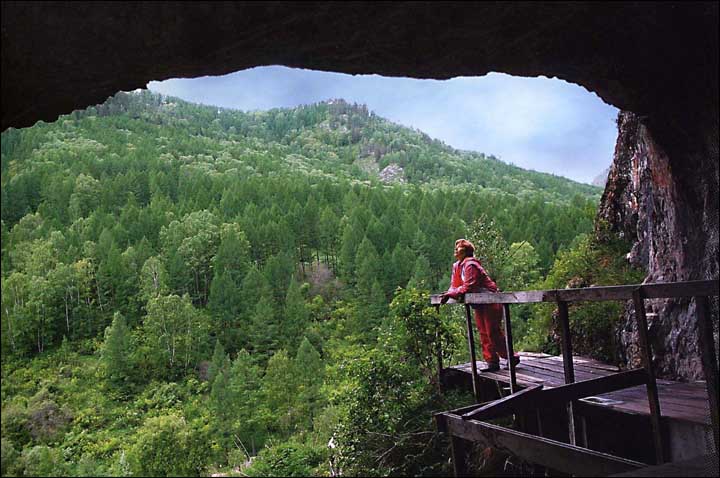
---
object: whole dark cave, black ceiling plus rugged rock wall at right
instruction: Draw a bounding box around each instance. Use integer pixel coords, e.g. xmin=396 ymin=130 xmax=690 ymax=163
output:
xmin=2 ymin=2 xmax=719 ymax=378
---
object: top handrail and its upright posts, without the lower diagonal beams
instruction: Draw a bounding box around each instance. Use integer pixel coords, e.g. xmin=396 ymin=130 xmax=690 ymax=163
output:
xmin=430 ymin=279 xmax=720 ymax=463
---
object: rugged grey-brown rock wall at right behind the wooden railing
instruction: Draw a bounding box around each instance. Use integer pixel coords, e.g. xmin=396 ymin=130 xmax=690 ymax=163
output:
xmin=598 ymin=112 xmax=718 ymax=380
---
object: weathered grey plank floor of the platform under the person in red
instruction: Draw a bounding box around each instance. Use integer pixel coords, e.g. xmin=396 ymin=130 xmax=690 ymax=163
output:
xmin=448 ymin=352 xmax=711 ymax=426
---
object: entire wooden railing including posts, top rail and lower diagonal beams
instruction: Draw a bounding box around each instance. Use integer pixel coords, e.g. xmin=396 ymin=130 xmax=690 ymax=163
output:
xmin=431 ymin=280 xmax=720 ymax=474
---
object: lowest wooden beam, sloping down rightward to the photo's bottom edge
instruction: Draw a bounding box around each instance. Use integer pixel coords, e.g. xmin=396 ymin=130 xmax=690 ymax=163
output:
xmin=438 ymin=414 xmax=647 ymax=476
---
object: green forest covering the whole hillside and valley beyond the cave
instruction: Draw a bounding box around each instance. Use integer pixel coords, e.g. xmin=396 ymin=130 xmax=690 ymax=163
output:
xmin=0 ymin=90 xmax=642 ymax=476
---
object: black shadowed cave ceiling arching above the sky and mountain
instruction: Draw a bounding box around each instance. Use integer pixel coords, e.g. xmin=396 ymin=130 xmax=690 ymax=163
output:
xmin=2 ymin=2 xmax=718 ymax=162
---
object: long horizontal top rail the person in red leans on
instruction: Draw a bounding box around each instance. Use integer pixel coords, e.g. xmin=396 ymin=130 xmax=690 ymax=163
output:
xmin=430 ymin=280 xmax=720 ymax=305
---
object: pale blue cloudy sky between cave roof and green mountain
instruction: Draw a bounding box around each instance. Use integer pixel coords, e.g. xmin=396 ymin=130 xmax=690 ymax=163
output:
xmin=147 ymin=66 xmax=618 ymax=183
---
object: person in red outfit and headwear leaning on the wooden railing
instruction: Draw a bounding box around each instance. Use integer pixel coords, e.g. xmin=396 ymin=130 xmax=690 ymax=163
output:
xmin=441 ymin=239 xmax=520 ymax=372
